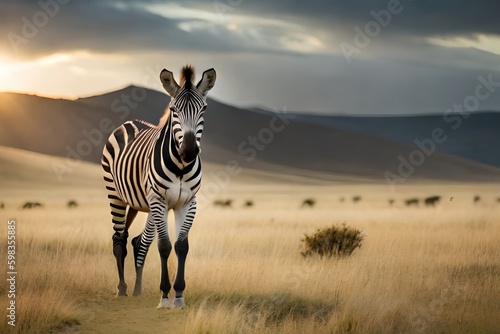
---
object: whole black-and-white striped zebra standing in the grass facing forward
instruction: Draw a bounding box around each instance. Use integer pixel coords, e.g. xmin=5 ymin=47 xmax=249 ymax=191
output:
xmin=101 ymin=66 xmax=216 ymax=308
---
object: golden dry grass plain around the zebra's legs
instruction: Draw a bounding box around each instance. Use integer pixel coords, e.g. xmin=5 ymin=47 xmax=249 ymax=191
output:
xmin=0 ymin=184 xmax=500 ymax=333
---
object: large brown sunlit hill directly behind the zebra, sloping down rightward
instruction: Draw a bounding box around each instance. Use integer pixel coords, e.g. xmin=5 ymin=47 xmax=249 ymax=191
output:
xmin=0 ymin=86 xmax=500 ymax=181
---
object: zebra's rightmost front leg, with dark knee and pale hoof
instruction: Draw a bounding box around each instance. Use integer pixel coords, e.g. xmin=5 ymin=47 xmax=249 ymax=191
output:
xmin=174 ymin=197 xmax=196 ymax=308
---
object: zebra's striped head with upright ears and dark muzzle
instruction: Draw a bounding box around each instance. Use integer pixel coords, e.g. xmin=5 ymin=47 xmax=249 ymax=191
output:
xmin=160 ymin=66 xmax=216 ymax=164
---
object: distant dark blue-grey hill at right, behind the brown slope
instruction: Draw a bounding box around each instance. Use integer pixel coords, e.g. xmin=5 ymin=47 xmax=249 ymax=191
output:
xmin=274 ymin=111 xmax=500 ymax=167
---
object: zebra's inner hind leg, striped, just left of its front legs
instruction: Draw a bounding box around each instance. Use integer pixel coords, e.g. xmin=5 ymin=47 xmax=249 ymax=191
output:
xmin=132 ymin=212 xmax=155 ymax=296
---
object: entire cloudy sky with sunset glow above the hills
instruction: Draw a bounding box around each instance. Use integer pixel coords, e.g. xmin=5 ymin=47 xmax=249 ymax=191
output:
xmin=0 ymin=0 xmax=500 ymax=115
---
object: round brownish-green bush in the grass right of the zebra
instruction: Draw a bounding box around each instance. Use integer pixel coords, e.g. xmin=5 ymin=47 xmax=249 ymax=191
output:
xmin=301 ymin=224 xmax=364 ymax=257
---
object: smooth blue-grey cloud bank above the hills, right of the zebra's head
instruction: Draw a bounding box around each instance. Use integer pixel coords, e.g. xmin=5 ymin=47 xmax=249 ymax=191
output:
xmin=201 ymin=51 xmax=500 ymax=115
